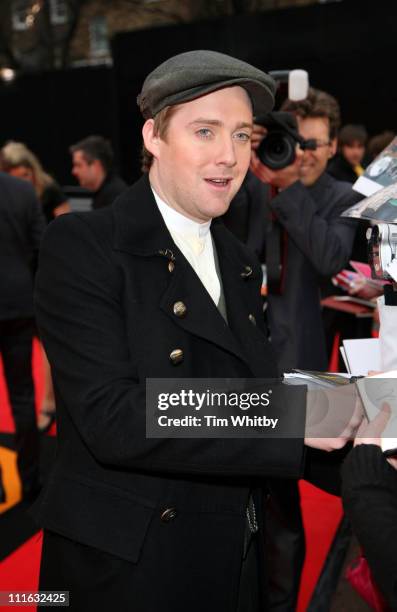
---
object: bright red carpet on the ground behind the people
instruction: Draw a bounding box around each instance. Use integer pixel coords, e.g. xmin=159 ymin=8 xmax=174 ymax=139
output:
xmin=0 ymin=342 xmax=342 ymax=612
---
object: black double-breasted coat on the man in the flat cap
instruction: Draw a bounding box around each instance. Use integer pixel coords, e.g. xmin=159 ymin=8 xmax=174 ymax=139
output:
xmin=34 ymin=177 xmax=304 ymax=612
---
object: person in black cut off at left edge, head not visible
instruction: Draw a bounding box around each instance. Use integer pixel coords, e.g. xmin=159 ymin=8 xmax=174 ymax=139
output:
xmin=0 ymin=172 xmax=45 ymax=500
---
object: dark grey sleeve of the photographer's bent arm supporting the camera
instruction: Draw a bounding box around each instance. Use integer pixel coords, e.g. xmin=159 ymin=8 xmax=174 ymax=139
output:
xmin=271 ymin=181 xmax=356 ymax=276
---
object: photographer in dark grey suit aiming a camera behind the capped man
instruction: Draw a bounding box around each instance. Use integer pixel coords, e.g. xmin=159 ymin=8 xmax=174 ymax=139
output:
xmin=240 ymin=88 xmax=357 ymax=611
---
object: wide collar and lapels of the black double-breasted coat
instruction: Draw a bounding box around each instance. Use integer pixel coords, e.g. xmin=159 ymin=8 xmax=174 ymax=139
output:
xmin=113 ymin=176 xmax=266 ymax=375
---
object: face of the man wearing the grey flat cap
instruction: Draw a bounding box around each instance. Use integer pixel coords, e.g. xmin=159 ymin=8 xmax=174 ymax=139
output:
xmin=143 ymin=87 xmax=253 ymax=223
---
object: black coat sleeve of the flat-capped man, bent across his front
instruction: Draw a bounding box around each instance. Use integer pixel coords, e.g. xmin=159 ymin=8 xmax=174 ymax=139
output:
xmin=35 ymin=213 xmax=305 ymax=478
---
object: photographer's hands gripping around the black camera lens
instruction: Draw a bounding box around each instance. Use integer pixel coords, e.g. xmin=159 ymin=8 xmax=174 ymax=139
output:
xmin=250 ymin=123 xmax=303 ymax=189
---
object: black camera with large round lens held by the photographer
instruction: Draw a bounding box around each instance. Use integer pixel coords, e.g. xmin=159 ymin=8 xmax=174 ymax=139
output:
xmin=255 ymin=111 xmax=317 ymax=170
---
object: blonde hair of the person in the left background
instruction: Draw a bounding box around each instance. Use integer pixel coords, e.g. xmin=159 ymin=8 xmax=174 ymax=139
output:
xmin=0 ymin=140 xmax=54 ymax=198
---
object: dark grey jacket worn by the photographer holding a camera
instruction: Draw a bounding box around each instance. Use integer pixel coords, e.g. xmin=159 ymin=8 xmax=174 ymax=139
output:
xmin=223 ymin=173 xmax=361 ymax=372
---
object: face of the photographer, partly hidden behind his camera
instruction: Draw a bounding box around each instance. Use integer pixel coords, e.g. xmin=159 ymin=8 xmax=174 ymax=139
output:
xmin=297 ymin=117 xmax=336 ymax=187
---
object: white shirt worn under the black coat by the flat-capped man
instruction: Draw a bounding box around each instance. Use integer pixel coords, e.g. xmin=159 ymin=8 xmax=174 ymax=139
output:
xmin=152 ymin=187 xmax=221 ymax=306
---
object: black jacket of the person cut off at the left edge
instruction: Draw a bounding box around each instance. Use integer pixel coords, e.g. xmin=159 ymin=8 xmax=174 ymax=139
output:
xmin=0 ymin=172 xmax=45 ymax=321
